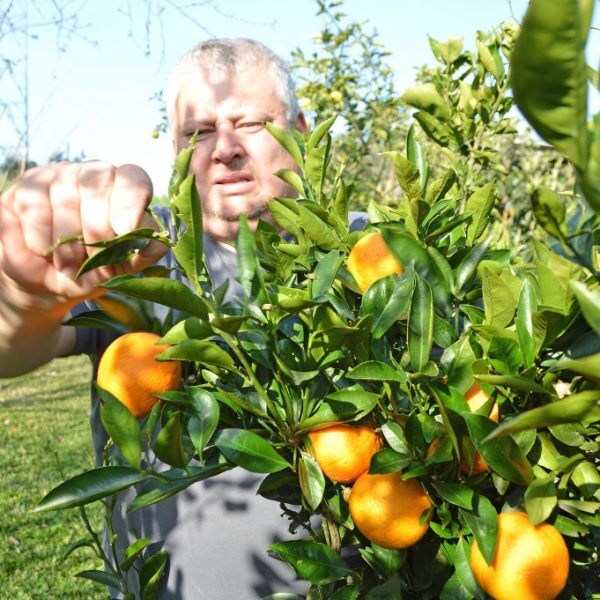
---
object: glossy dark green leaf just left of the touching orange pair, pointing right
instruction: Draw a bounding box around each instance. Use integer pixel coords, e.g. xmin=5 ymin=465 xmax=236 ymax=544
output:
xmin=215 ymin=429 xmax=290 ymax=473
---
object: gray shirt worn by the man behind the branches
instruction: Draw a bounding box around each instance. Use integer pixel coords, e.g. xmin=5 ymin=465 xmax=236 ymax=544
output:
xmin=74 ymin=208 xmax=366 ymax=600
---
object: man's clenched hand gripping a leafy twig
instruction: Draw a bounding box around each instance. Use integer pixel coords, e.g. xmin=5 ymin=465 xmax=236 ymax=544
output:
xmin=0 ymin=161 xmax=166 ymax=308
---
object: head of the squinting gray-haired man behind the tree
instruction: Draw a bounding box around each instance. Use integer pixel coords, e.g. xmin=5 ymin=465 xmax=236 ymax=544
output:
xmin=165 ymin=39 xmax=306 ymax=240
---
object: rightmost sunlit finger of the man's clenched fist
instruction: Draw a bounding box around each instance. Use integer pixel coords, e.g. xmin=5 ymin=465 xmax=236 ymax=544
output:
xmin=110 ymin=165 xmax=152 ymax=235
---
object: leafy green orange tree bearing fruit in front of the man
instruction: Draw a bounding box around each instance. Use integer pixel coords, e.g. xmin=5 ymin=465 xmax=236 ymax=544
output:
xmin=38 ymin=0 xmax=600 ymax=600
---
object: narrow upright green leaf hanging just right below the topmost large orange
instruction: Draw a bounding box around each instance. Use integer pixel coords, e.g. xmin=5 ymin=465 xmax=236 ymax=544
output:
xmin=406 ymin=274 xmax=433 ymax=373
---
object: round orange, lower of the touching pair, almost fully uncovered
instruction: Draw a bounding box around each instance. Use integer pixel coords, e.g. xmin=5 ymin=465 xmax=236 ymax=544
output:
xmin=349 ymin=473 xmax=431 ymax=548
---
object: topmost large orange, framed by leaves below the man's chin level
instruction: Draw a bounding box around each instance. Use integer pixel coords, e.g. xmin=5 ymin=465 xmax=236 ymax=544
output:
xmin=347 ymin=231 xmax=404 ymax=294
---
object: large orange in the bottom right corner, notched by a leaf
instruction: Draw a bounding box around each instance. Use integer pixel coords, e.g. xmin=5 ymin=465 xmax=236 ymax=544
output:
xmin=471 ymin=512 xmax=569 ymax=600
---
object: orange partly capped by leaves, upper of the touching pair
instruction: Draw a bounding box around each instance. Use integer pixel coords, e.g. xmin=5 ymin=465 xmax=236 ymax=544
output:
xmin=308 ymin=423 xmax=382 ymax=483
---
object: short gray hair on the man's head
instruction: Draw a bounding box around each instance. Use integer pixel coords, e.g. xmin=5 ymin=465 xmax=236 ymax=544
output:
xmin=164 ymin=38 xmax=300 ymax=125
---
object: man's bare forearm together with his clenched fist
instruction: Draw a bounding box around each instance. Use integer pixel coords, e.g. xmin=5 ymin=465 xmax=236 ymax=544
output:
xmin=0 ymin=161 xmax=166 ymax=377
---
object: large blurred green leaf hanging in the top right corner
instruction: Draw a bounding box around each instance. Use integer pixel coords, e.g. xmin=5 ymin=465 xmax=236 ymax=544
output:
xmin=511 ymin=0 xmax=589 ymax=170
